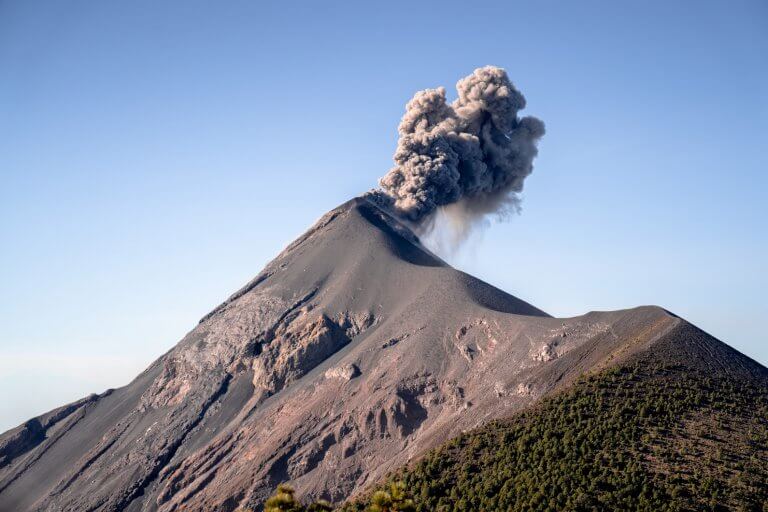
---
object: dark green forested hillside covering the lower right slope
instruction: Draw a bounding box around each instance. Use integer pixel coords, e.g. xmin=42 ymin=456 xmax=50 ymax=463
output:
xmin=268 ymin=364 xmax=768 ymax=512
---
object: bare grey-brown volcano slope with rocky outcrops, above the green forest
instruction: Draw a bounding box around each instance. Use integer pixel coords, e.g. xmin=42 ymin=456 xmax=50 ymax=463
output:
xmin=0 ymin=199 xmax=766 ymax=511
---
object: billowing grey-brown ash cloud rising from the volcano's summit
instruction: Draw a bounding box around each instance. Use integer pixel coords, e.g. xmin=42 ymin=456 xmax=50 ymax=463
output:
xmin=376 ymin=66 xmax=544 ymax=234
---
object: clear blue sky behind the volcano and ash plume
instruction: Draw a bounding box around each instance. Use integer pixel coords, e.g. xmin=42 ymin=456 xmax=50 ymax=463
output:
xmin=0 ymin=0 xmax=768 ymax=430
